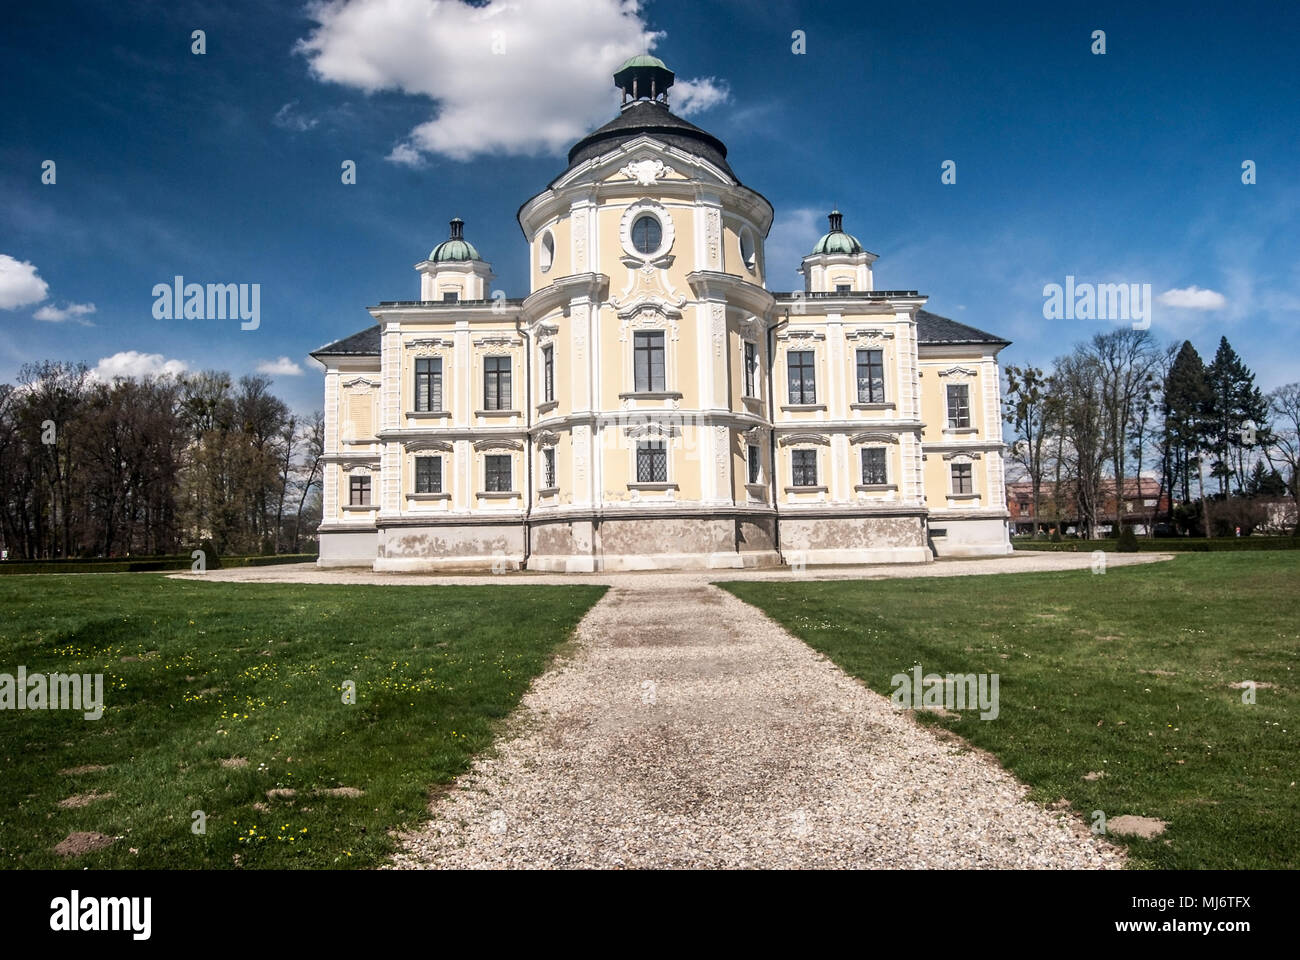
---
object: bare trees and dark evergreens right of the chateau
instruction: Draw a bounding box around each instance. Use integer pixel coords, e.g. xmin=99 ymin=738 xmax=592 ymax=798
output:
xmin=1004 ymin=329 xmax=1300 ymax=539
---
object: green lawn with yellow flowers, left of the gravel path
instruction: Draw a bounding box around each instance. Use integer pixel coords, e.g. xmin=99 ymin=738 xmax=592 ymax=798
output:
xmin=0 ymin=574 xmax=605 ymax=869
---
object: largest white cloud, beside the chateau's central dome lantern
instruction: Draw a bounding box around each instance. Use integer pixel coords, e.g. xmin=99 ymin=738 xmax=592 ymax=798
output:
xmin=296 ymin=0 xmax=727 ymax=165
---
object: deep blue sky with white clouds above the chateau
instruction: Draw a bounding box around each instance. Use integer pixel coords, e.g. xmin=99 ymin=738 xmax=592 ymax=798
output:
xmin=0 ymin=0 xmax=1300 ymax=411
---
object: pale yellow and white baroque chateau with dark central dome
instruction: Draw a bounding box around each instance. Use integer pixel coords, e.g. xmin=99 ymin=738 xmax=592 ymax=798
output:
xmin=312 ymin=56 xmax=1010 ymax=571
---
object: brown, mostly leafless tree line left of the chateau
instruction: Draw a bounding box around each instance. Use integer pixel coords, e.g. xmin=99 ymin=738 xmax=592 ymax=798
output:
xmin=0 ymin=360 xmax=325 ymax=559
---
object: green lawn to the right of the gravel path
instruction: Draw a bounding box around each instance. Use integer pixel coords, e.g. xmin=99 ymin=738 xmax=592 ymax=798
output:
xmin=720 ymin=553 xmax=1300 ymax=869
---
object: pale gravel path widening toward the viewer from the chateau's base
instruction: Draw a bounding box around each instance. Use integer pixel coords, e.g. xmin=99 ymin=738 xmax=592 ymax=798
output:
xmin=178 ymin=554 xmax=1164 ymax=869
